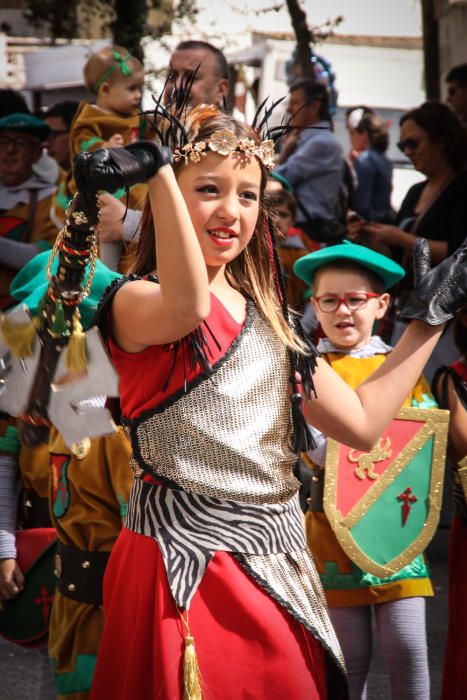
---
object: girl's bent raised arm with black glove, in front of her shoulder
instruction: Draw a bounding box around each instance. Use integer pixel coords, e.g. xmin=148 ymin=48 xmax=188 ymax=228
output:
xmin=74 ymin=142 xmax=210 ymax=352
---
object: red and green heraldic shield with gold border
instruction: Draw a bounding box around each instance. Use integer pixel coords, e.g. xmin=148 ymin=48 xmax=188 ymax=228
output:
xmin=324 ymin=408 xmax=449 ymax=578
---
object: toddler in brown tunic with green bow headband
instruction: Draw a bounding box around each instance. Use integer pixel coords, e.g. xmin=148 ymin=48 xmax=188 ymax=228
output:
xmin=57 ymin=46 xmax=154 ymax=270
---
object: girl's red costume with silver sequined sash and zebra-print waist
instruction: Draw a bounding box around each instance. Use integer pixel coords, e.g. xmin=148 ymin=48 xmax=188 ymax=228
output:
xmin=92 ymin=280 xmax=346 ymax=700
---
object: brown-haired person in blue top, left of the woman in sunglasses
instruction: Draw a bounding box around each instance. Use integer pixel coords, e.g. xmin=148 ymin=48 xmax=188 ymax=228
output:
xmin=351 ymin=110 xmax=394 ymax=223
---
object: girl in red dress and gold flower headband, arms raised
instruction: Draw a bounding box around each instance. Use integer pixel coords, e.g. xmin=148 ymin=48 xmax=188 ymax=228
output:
xmin=71 ymin=101 xmax=467 ymax=700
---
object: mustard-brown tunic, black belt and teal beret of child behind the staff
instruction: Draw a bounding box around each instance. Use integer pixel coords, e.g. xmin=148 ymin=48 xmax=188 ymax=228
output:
xmin=5 ymin=249 xmax=133 ymax=700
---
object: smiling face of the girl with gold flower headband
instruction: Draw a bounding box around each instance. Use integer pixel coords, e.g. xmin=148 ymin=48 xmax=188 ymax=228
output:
xmin=177 ymin=152 xmax=262 ymax=268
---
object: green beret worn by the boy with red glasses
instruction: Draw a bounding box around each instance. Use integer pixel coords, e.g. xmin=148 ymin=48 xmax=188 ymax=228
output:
xmin=293 ymin=241 xmax=405 ymax=290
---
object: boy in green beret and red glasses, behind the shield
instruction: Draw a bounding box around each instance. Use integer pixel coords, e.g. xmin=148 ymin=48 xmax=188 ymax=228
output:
xmin=294 ymin=242 xmax=436 ymax=700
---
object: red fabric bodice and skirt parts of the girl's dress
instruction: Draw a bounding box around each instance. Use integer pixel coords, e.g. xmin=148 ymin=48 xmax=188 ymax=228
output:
xmin=91 ymin=297 xmax=346 ymax=700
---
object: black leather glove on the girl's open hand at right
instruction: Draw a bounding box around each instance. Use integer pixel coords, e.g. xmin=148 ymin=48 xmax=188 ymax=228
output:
xmin=400 ymin=238 xmax=467 ymax=326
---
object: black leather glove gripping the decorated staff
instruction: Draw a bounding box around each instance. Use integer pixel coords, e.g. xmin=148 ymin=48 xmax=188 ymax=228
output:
xmin=73 ymin=141 xmax=172 ymax=192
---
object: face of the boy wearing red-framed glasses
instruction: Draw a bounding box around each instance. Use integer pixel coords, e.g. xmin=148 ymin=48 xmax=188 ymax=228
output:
xmin=311 ymin=268 xmax=389 ymax=349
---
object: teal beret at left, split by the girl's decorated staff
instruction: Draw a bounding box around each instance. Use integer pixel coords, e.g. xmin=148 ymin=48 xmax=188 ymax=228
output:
xmin=10 ymin=250 xmax=121 ymax=328
